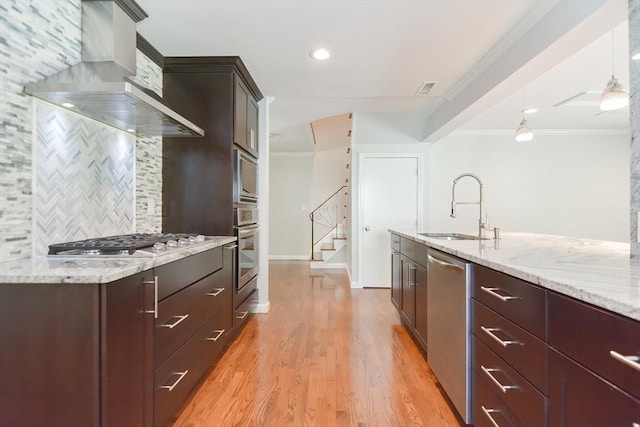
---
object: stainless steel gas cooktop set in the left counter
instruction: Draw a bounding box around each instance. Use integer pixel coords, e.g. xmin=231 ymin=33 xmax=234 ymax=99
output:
xmin=49 ymin=233 xmax=206 ymax=257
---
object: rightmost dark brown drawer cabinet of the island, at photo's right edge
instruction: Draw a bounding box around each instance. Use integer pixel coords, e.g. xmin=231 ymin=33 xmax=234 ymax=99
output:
xmin=549 ymin=292 xmax=640 ymax=426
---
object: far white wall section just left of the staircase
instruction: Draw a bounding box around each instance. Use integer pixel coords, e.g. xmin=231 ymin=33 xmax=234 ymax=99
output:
xmin=269 ymin=153 xmax=313 ymax=260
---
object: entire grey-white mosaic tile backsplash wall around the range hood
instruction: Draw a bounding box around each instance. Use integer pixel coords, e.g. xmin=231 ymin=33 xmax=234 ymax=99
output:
xmin=0 ymin=0 xmax=162 ymax=262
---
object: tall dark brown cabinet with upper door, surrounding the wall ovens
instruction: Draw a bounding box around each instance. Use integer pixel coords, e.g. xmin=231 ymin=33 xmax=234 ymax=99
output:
xmin=162 ymin=57 xmax=262 ymax=235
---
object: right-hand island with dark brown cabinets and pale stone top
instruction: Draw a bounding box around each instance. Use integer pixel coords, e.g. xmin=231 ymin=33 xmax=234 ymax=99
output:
xmin=390 ymin=230 xmax=640 ymax=427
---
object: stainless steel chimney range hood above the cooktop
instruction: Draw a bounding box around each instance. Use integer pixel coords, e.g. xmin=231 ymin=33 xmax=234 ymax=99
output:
xmin=24 ymin=0 xmax=204 ymax=137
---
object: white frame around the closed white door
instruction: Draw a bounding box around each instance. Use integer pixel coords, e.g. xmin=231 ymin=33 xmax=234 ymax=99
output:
xmin=352 ymin=152 xmax=424 ymax=288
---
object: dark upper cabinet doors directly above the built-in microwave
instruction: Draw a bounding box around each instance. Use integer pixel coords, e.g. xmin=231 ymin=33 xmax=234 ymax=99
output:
xmin=233 ymin=76 xmax=258 ymax=158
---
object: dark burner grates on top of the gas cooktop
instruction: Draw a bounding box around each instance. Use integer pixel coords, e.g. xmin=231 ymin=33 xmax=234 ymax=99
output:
xmin=49 ymin=233 xmax=195 ymax=255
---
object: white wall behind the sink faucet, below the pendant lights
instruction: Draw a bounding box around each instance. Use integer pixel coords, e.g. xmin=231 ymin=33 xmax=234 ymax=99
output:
xmin=428 ymin=131 xmax=630 ymax=241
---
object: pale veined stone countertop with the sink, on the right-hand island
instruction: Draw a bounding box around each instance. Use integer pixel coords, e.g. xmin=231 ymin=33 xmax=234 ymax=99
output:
xmin=389 ymin=230 xmax=640 ymax=321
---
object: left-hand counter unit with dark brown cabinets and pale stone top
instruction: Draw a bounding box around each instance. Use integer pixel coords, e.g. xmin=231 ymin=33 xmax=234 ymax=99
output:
xmin=0 ymin=236 xmax=240 ymax=427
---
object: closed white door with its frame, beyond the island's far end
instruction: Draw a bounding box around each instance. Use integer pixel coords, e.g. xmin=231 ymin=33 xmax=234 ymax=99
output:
xmin=360 ymin=155 xmax=420 ymax=288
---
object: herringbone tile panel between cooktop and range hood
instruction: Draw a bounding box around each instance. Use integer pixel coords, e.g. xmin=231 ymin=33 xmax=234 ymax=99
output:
xmin=33 ymin=102 xmax=135 ymax=255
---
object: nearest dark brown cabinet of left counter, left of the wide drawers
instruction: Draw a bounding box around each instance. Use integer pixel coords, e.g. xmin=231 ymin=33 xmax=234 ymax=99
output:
xmin=0 ymin=271 xmax=154 ymax=427
